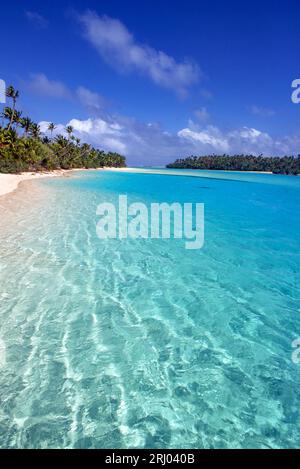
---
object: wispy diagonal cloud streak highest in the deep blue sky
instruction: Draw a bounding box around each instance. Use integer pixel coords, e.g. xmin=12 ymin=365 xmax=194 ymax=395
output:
xmin=79 ymin=11 xmax=201 ymax=96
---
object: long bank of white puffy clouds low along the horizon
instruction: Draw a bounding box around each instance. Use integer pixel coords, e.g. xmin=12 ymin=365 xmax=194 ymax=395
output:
xmin=40 ymin=110 xmax=300 ymax=165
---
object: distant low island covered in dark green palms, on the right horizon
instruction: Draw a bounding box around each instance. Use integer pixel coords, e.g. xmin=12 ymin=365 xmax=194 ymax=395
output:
xmin=167 ymin=155 xmax=300 ymax=176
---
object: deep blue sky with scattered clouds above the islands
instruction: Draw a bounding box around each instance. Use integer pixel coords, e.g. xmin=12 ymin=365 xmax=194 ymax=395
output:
xmin=0 ymin=0 xmax=300 ymax=164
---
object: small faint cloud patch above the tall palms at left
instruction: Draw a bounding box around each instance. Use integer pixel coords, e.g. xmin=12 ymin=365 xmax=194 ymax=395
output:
xmin=27 ymin=73 xmax=71 ymax=99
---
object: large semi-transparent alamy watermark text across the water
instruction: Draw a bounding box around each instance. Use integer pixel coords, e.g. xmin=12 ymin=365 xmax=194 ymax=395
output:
xmin=96 ymin=195 xmax=204 ymax=249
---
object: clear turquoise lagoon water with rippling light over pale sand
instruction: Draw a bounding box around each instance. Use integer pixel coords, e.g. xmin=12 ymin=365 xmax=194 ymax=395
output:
xmin=0 ymin=170 xmax=300 ymax=448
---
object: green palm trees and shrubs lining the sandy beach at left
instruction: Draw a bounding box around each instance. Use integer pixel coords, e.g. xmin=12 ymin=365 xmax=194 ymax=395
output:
xmin=0 ymin=86 xmax=126 ymax=173
